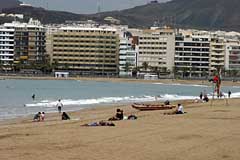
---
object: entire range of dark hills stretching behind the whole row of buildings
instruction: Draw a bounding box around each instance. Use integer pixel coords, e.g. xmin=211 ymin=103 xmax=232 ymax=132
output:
xmin=0 ymin=0 xmax=240 ymax=31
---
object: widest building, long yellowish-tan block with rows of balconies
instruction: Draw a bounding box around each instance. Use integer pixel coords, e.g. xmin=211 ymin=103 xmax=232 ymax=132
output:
xmin=52 ymin=27 xmax=119 ymax=75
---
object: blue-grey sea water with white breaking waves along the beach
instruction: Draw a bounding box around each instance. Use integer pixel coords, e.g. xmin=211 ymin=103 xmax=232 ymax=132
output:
xmin=0 ymin=80 xmax=240 ymax=120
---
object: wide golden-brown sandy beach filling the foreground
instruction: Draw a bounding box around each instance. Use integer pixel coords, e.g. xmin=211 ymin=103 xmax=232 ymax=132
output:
xmin=0 ymin=99 xmax=240 ymax=160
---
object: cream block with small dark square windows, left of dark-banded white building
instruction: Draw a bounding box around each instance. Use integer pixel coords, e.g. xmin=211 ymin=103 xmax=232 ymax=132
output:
xmin=134 ymin=28 xmax=175 ymax=71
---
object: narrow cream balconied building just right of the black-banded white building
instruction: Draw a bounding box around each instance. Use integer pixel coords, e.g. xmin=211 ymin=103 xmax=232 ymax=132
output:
xmin=210 ymin=35 xmax=226 ymax=74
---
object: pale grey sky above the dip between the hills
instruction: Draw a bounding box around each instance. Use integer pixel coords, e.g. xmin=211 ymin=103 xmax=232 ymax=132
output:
xmin=20 ymin=0 xmax=167 ymax=14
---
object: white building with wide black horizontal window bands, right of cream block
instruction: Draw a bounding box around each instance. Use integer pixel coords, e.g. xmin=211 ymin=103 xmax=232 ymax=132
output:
xmin=175 ymin=34 xmax=210 ymax=77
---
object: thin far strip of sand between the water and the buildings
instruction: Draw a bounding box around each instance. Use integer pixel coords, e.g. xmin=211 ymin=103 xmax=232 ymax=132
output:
xmin=0 ymin=76 xmax=240 ymax=86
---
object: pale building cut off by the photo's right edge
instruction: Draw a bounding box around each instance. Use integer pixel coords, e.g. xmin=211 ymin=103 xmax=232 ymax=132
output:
xmin=225 ymin=40 xmax=240 ymax=70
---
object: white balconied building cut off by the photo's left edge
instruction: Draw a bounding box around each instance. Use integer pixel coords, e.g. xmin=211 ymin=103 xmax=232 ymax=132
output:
xmin=0 ymin=26 xmax=14 ymax=69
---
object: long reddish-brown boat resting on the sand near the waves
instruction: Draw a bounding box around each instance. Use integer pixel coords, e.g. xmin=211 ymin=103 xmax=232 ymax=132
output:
xmin=132 ymin=103 xmax=176 ymax=111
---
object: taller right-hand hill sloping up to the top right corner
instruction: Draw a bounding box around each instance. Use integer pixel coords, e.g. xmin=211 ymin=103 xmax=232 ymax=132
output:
xmin=93 ymin=0 xmax=240 ymax=31
